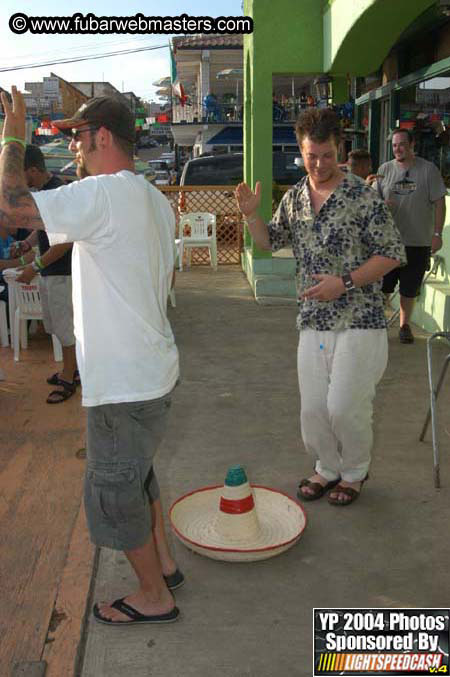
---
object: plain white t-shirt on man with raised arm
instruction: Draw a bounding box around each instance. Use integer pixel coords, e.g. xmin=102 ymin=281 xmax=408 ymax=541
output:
xmin=33 ymin=170 xmax=178 ymax=407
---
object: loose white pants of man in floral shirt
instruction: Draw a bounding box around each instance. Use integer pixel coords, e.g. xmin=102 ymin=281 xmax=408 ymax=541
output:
xmin=297 ymin=329 xmax=388 ymax=482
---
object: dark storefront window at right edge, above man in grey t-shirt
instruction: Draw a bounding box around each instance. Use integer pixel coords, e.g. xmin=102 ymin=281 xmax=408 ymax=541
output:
xmin=398 ymin=72 xmax=450 ymax=188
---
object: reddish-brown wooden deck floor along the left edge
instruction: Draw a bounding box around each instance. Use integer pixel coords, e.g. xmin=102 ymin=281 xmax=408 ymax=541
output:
xmin=0 ymin=332 xmax=89 ymax=676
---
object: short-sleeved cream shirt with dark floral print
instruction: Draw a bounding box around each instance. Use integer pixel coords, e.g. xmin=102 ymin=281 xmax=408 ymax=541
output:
xmin=268 ymin=173 xmax=406 ymax=331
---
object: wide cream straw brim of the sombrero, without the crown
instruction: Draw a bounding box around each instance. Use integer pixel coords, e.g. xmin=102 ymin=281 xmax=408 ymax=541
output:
xmin=169 ymin=484 xmax=306 ymax=562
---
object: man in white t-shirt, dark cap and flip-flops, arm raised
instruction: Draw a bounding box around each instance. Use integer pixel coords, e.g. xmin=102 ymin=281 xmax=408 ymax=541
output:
xmin=0 ymin=87 xmax=184 ymax=625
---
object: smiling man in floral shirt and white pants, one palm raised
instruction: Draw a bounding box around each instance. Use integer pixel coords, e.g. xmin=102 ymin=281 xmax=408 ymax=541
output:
xmin=236 ymin=109 xmax=406 ymax=506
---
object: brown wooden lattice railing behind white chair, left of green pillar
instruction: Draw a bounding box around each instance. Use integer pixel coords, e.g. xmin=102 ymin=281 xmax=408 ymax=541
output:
xmin=158 ymin=186 xmax=243 ymax=265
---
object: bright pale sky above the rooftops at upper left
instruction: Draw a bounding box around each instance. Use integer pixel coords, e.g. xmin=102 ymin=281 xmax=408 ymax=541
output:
xmin=0 ymin=0 xmax=243 ymax=101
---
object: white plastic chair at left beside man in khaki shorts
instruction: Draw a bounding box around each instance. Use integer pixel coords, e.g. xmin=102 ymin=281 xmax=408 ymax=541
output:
xmin=13 ymin=280 xmax=63 ymax=362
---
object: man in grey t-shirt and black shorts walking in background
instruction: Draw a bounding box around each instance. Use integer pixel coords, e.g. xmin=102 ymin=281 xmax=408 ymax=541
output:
xmin=377 ymin=129 xmax=447 ymax=343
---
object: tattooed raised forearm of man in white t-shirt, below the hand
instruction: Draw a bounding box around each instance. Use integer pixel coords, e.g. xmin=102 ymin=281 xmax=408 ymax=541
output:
xmin=0 ymin=143 xmax=45 ymax=230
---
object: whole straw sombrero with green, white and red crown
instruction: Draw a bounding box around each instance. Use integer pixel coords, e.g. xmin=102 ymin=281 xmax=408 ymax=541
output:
xmin=169 ymin=465 xmax=306 ymax=562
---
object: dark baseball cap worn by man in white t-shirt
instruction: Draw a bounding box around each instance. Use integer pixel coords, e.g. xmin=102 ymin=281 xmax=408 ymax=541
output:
xmin=52 ymin=96 xmax=136 ymax=143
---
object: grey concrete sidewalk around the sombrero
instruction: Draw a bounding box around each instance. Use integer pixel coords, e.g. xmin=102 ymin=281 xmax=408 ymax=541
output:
xmin=80 ymin=267 xmax=450 ymax=677
